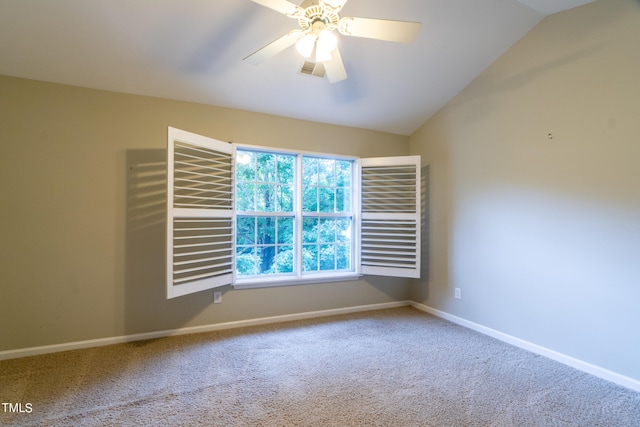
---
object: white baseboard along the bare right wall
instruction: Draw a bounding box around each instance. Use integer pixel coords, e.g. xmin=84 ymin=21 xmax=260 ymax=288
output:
xmin=409 ymin=301 xmax=640 ymax=392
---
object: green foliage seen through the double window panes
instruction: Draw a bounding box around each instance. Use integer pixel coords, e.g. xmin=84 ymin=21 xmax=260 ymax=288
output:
xmin=236 ymin=150 xmax=352 ymax=276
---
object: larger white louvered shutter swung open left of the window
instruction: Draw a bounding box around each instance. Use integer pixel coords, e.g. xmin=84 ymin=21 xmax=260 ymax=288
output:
xmin=167 ymin=128 xmax=234 ymax=298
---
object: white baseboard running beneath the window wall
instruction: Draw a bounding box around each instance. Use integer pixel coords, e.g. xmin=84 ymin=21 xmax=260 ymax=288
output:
xmin=0 ymin=301 xmax=410 ymax=360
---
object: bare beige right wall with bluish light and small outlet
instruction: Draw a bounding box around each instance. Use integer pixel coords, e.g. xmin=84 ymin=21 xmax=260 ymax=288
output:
xmin=411 ymin=0 xmax=640 ymax=380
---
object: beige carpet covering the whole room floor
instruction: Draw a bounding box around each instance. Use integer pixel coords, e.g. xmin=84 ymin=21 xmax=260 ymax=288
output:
xmin=0 ymin=308 xmax=640 ymax=427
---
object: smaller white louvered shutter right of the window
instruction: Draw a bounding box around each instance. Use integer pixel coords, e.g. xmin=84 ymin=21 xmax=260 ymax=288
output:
xmin=360 ymin=156 xmax=420 ymax=278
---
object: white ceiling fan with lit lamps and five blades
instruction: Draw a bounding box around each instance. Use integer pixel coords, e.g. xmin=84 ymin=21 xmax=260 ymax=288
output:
xmin=244 ymin=0 xmax=421 ymax=83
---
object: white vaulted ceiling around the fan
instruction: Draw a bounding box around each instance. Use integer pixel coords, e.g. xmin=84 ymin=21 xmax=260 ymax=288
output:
xmin=0 ymin=0 xmax=593 ymax=135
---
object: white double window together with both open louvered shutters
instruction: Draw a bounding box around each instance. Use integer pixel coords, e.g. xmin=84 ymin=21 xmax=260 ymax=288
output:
xmin=167 ymin=128 xmax=420 ymax=298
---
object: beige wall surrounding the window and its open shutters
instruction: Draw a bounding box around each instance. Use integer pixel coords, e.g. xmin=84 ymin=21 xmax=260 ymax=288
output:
xmin=0 ymin=76 xmax=409 ymax=351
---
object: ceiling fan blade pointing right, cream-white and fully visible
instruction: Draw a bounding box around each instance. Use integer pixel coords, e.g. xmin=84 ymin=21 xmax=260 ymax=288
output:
xmin=338 ymin=18 xmax=422 ymax=43
